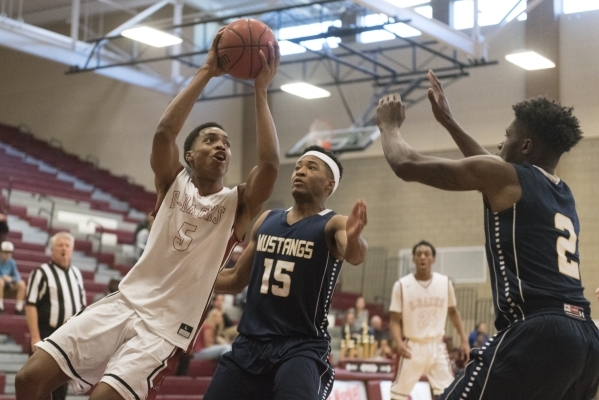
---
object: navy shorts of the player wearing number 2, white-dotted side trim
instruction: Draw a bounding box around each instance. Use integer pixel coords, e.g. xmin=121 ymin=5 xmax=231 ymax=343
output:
xmin=439 ymin=313 xmax=599 ymax=400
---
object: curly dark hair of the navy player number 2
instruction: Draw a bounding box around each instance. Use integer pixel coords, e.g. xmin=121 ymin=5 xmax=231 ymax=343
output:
xmin=512 ymin=96 xmax=582 ymax=154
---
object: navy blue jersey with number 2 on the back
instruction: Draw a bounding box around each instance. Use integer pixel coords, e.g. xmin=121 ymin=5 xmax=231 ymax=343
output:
xmin=485 ymin=164 xmax=589 ymax=329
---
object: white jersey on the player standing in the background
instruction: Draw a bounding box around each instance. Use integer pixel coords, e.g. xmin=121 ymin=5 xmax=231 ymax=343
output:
xmin=389 ymin=272 xmax=456 ymax=340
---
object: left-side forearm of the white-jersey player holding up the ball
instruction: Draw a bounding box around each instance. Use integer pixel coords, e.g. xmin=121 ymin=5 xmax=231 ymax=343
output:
xmin=156 ymin=67 xmax=213 ymax=141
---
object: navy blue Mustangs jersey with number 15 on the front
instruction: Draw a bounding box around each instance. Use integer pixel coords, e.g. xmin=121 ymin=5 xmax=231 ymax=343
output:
xmin=238 ymin=210 xmax=343 ymax=339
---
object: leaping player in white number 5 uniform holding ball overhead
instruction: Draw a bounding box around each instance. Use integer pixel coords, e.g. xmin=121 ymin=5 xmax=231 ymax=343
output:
xmin=16 ymin=28 xmax=280 ymax=400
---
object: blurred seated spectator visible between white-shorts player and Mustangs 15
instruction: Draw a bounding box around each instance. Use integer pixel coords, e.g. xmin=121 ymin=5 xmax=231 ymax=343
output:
xmin=193 ymin=308 xmax=231 ymax=360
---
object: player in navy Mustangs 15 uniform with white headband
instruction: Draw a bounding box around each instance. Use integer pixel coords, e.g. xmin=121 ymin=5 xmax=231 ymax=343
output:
xmin=204 ymin=146 xmax=368 ymax=400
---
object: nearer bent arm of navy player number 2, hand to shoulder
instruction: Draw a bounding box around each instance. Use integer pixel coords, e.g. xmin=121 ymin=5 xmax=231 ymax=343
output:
xmin=377 ymin=94 xmax=521 ymax=211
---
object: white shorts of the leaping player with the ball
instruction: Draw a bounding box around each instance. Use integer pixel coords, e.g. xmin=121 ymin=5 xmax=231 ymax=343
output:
xmin=35 ymin=292 xmax=183 ymax=400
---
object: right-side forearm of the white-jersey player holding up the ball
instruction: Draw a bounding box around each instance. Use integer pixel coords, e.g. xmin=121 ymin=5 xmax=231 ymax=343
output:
xmin=255 ymin=89 xmax=279 ymax=177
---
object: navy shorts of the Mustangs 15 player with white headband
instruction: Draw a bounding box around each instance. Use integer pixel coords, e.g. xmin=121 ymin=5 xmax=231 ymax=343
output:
xmin=204 ymin=335 xmax=334 ymax=400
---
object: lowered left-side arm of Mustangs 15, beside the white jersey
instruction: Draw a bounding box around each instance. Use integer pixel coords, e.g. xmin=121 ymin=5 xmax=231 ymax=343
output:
xmin=214 ymin=210 xmax=270 ymax=293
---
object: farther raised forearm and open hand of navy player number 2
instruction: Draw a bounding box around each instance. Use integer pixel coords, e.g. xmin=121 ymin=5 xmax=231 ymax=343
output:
xmin=428 ymin=70 xmax=491 ymax=157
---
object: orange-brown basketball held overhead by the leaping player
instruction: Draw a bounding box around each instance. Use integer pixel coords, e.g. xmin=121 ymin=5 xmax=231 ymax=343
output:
xmin=217 ymin=18 xmax=278 ymax=80
